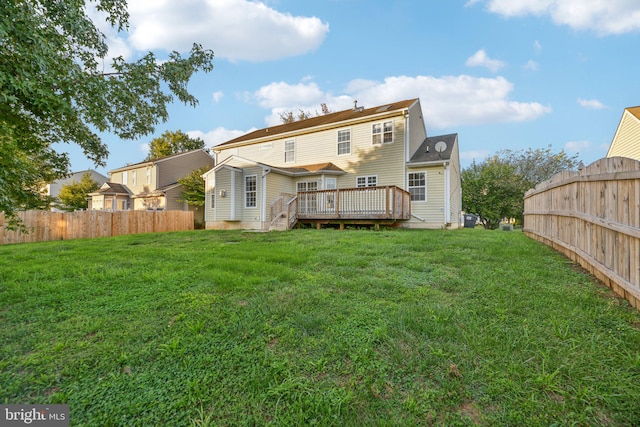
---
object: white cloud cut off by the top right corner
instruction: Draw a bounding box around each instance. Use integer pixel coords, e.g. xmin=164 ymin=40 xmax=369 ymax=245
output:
xmin=480 ymin=0 xmax=640 ymax=35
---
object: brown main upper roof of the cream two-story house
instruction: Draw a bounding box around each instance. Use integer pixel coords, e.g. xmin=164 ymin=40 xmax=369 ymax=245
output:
xmin=214 ymin=98 xmax=419 ymax=150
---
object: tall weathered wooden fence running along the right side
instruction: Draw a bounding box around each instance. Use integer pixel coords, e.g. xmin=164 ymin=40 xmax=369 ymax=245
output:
xmin=524 ymin=157 xmax=640 ymax=309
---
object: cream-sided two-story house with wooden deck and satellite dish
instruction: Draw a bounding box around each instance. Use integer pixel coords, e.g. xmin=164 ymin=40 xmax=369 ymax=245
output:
xmin=204 ymin=99 xmax=462 ymax=230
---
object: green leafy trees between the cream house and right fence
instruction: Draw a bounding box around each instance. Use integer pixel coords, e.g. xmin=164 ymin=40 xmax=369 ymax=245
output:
xmin=461 ymin=147 xmax=578 ymax=229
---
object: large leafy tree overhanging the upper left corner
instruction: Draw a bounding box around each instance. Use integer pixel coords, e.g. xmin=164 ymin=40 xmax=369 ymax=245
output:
xmin=0 ymin=0 xmax=213 ymax=231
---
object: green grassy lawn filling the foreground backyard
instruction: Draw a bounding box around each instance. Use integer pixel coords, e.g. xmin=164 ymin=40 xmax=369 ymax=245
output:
xmin=0 ymin=229 xmax=640 ymax=426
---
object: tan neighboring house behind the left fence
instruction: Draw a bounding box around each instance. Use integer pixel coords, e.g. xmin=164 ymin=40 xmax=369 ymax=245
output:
xmin=89 ymin=150 xmax=215 ymax=220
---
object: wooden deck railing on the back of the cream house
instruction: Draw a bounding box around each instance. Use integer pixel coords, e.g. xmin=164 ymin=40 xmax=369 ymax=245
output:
xmin=298 ymin=185 xmax=411 ymax=220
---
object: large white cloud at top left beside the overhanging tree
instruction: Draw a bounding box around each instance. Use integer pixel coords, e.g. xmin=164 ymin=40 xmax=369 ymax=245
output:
xmin=124 ymin=0 xmax=329 ymax=61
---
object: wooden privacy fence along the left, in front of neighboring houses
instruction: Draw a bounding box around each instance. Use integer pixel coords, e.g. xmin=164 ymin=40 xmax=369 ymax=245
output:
xmin=0 ymin=211 xmax=194 ymax=244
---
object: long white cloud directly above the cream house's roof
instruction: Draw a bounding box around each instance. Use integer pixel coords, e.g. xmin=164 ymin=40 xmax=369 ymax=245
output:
xmin=252 ymin=75 xmax=551 ymax=128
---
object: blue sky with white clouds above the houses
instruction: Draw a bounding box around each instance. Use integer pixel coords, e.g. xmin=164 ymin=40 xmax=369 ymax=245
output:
xmin=59 ymin=0 xmax=640 ymax=173
